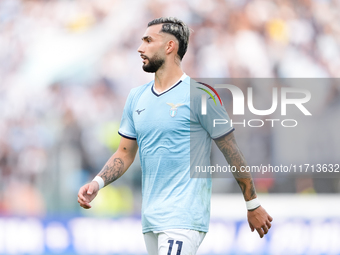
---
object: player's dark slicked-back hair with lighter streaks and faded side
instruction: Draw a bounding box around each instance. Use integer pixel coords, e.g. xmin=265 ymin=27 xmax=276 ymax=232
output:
xmin=148 ymin=17 xmax=190 ymax=60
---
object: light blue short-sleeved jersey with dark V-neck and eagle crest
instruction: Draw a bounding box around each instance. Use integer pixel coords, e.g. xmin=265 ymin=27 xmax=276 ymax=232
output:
xmin=119 ymin=74 xmax=233 ymax=233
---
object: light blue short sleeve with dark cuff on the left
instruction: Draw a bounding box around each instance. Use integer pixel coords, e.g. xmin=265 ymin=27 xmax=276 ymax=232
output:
xmin=118 ymin=90 xmax=137 ymax=140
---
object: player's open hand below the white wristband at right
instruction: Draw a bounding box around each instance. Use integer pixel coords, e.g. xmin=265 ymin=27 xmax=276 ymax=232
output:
xmin=248 ymin=206 xmax=273 ymax=238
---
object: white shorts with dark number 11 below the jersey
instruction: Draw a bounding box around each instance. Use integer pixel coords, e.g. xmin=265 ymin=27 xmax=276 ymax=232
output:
xmin=144 ymin=229 xmax=206 ymax=255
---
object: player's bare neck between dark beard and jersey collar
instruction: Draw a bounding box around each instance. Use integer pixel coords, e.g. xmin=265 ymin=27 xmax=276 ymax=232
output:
xmin=154 ymin=62 xmax=183 ymax=93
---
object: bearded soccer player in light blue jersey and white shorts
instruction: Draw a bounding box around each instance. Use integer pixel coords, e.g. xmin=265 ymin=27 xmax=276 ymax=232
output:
xmin=78 ymin=17 xmax=272 ymax=255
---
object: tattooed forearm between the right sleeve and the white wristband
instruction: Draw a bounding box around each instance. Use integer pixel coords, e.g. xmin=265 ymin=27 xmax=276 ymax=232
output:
xmin=215 ymin=133 xmax=256 ymax=201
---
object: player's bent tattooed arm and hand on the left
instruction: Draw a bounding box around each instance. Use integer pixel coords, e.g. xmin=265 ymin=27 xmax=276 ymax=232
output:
xmin=78 ymin=137 xmax=138 ymax=209
